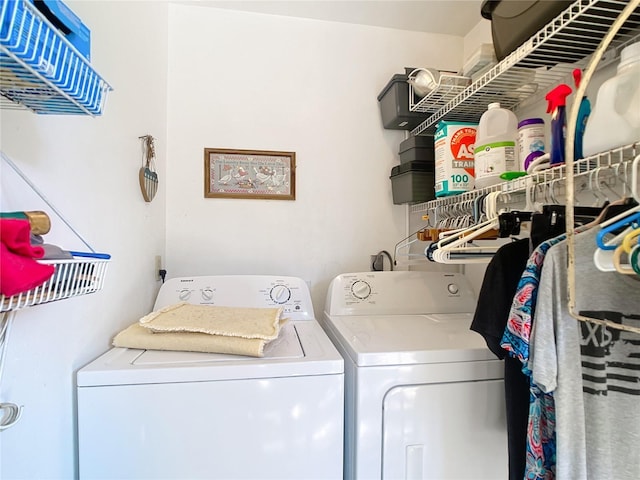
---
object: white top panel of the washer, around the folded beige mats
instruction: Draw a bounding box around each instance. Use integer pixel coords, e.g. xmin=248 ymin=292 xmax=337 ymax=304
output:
xmin=77 ymin=320 xmax=344 ymax=387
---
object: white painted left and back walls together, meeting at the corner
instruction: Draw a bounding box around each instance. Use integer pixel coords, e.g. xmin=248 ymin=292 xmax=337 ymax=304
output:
xmin=0 ymin=1 xmax=462 ymax=480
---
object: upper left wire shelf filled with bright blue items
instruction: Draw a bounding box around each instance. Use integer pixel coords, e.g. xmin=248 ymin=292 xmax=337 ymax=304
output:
xmin=0 ymin=0 xmax=111 ymax=116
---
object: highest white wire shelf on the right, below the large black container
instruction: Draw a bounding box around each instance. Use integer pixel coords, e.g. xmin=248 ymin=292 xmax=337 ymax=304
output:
xmin=410 ymin=0 xmax=640 ymax=135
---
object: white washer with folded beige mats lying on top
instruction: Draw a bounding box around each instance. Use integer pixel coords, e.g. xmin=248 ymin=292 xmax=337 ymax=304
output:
xmin=77 ymin=275 xmax=344 ymax=480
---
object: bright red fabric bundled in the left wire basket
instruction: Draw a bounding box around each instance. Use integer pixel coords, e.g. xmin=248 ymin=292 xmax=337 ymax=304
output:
xmin=0 ymin=218 xmax=55 ymax=297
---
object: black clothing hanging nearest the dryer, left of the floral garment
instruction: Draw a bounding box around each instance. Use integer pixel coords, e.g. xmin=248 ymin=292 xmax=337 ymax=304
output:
xmin=471 ymin=239 xmax=529 ymax=480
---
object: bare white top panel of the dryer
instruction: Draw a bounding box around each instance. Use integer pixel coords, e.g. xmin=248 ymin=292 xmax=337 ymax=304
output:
xmin=327 ymin=313 xmax=496 ymax=367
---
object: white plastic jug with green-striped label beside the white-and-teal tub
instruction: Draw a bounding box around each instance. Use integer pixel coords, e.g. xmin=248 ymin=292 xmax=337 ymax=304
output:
xmin=474 ymin=103 xmax=520 ymax=188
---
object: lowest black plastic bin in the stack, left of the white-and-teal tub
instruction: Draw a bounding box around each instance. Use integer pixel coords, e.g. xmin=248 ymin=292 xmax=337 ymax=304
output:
xmin=389 ymin=162 xmax=436 ymax=205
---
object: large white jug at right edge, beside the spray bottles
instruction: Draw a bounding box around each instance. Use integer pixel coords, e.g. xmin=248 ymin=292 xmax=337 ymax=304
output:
xmin=583 ymin=42 xmax=640 ymax=156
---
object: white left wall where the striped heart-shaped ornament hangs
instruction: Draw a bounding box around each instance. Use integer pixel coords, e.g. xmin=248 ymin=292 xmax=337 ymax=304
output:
xmin=0 ymin=1 xmax=167 ymax=480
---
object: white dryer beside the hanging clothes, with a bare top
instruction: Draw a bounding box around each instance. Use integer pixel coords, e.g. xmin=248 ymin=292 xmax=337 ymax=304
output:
xmin=322 ymin=272 xmax=508 ymax=480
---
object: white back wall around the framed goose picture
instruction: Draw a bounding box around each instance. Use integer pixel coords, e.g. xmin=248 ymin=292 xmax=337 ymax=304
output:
xmin=167 ymin=5 xmax=463 ymax=314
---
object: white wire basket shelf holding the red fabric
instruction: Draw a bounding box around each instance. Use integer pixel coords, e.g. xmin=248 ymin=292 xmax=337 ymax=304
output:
xmin=0 ymin=258 xmax=109 ymax=312
